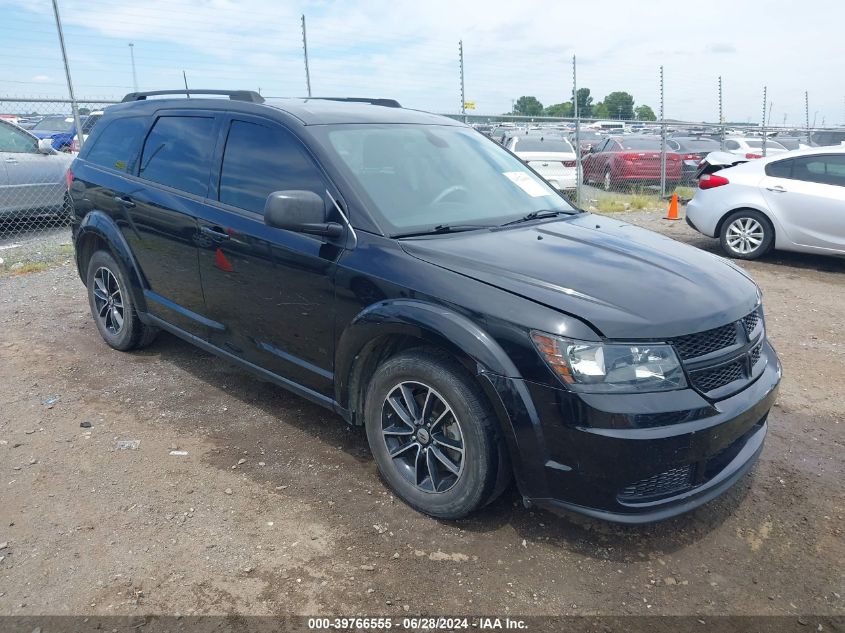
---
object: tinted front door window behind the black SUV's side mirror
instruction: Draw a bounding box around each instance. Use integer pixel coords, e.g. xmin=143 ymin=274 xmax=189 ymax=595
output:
xmin=219 ymin=121 xmax=326 ymax=214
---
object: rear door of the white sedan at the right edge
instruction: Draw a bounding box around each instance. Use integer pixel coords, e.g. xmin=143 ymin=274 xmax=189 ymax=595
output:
xmin=760 ymin=153 xmax=845 ymax=252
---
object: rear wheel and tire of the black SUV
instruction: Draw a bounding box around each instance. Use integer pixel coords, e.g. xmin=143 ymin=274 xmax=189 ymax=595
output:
xmin=85 ymin=251 xmax=158 ymax=352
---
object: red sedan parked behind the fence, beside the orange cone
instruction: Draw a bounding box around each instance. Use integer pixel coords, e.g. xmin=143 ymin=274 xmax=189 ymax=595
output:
xmin=583 ymin=136 xmax=683 ymax=191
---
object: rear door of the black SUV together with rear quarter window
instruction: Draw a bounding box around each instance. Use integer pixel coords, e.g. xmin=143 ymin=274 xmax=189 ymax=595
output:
xmin=84 ymin=110 xmax=219 ymax=339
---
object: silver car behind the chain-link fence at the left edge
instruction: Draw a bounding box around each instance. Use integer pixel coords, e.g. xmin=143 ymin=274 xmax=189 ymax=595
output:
xmin=0 ymin=121 xmax=73 ymax=220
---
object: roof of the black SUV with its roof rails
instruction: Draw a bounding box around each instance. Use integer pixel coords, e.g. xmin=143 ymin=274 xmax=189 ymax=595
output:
xmin=108 ymin=97 xmax=464 ymax=126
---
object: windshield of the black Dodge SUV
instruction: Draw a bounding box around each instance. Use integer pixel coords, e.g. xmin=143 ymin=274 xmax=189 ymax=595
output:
xmin=328 ymin=125 xmax=574 ymax=235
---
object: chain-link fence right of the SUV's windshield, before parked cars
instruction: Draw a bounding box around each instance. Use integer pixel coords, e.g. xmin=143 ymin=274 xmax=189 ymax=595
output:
xmin=469 ymin=117 xmax=845 ymax=211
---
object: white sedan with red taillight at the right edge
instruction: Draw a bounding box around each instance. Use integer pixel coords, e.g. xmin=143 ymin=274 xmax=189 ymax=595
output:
xmin=687 ymin=147 xmax=845 ymax=259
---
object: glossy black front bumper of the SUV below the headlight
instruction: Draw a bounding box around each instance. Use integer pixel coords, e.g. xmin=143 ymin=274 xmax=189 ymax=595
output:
xmin=487 ymin=342 xmax=781 ymax=523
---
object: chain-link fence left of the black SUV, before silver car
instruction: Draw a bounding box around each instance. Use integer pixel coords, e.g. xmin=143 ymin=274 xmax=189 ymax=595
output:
xmin=0 ymin=96 xmax=115 ymax=247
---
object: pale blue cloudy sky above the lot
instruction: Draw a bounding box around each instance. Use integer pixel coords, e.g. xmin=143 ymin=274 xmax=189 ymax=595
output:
xmin=0 ymin=0 xmax=845 ymax=126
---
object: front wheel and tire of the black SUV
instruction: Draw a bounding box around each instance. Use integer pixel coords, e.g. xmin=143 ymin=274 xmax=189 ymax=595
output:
xmin=364 ymin=349 xmax=509 ymax=519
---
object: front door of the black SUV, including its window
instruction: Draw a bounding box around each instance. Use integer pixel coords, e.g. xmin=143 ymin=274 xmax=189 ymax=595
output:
xmin=199 ymin=115 xmax=343 ymax=397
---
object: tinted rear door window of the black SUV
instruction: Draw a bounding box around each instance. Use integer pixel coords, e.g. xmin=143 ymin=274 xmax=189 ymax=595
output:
xmin=138 ymin=116 xmax=214 ymax=196
